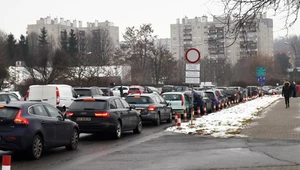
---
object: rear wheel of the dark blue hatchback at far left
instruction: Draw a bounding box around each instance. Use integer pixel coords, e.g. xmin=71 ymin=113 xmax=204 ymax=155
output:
xmin=30 ymin=134 xmax=44 ymax=160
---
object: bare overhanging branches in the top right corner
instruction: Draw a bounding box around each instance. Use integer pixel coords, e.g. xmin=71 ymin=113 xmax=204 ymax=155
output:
xmin=222 ymin=0 xmax=300 ymax=34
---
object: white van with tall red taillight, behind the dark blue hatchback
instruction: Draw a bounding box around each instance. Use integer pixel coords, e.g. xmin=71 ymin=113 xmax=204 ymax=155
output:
xmin=26 ymin=84 xmax=78 ymax=111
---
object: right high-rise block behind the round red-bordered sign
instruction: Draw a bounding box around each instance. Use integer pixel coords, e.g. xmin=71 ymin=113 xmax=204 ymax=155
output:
xmin=170 ymin=14 xmax=274 ymax=84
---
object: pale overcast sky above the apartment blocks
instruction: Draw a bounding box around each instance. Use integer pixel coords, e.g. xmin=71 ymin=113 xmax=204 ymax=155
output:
xmin=0 ymin=0 xmax=300 ymax=39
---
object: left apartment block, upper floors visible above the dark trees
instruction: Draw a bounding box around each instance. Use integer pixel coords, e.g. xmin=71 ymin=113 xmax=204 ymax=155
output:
xmin=27 ymin=16 xmax=119 ymax=50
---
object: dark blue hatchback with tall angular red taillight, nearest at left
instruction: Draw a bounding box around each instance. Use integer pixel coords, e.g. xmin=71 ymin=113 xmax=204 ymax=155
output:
xmin=0 ymin=101 xmax=79 ymax=159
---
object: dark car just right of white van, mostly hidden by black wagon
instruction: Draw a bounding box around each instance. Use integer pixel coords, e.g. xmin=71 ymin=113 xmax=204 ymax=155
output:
xmin=74 ymin=86 xmax=104 ymax=97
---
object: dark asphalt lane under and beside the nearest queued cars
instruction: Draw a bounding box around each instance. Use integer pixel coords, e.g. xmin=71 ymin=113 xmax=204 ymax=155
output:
xmin=0 ymin=123 xmax=171 ymax=170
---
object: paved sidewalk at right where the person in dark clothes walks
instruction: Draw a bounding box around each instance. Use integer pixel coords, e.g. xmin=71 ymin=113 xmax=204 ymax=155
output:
xmin=241 ymin=97 xmax=300 ymax=140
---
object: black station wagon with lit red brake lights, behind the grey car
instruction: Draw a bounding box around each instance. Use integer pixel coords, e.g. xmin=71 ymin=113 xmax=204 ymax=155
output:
xmin=66 ymin=96 xmax=142 ymax=139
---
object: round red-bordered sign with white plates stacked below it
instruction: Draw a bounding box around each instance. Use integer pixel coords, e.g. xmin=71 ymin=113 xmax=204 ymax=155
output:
xmin=185 ymin=48 xmax=200 ymax=87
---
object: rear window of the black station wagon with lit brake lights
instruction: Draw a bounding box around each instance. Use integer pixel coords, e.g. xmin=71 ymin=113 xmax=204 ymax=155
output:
xmin=69 ymin=100 xmax=107 ymax=110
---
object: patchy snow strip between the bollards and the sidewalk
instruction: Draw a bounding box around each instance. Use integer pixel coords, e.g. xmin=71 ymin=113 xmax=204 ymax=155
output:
xmin=166 ymin=95 xmax=282 ymax=138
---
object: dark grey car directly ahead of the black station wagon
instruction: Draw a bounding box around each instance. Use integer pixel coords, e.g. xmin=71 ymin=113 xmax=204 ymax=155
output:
xmin=125 ymin=93 xmax=173 ymax=126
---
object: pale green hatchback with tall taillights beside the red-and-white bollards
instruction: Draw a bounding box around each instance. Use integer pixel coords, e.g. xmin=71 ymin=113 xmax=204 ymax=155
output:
xmin=162 ymin=92 xmax=194 ymax=116
